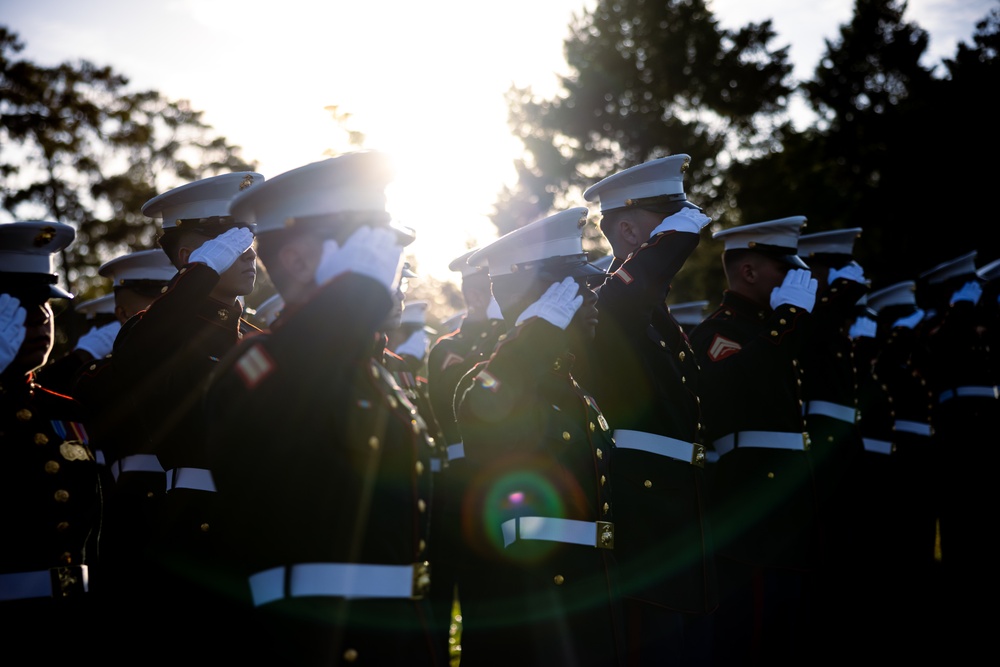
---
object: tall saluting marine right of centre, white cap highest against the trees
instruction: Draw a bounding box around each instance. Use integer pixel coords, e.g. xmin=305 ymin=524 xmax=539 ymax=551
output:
xmin=579 ymin=154 xmax=718 ymax=665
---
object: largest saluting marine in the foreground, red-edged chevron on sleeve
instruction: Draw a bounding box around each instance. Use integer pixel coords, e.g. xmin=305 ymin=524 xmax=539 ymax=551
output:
xmin=206 ymin=151 xmax=447 ymax=666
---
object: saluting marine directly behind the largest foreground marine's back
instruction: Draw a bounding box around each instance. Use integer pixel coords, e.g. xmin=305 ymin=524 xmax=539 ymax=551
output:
xmin=95 ymin=172 xmax=264 ymax=661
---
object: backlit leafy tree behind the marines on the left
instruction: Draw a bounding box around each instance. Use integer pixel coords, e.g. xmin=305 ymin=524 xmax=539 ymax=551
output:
xmin=0 ymin=26 xmax=256 ymax=299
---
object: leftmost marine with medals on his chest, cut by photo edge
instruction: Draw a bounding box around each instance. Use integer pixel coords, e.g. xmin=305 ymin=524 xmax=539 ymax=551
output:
xmin=0 ymin=220 xmax=101 ymax=664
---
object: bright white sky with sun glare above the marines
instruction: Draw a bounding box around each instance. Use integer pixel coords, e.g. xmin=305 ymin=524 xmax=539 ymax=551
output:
xmin=0 ymin=0 xmax=1000 ymax=280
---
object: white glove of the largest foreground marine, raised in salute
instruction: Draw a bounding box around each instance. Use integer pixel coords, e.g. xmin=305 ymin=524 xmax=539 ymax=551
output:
xmin=315 ymin=227 xmax=403 ymax=292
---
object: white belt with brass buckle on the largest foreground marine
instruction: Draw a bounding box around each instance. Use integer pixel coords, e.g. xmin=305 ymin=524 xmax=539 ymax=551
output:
xmin=249 ymin=563 xmax=430 ymax=607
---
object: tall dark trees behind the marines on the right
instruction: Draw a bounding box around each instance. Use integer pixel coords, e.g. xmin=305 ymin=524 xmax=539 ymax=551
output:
xmin=493 ymin=0 xmax=1000 ymax=301
